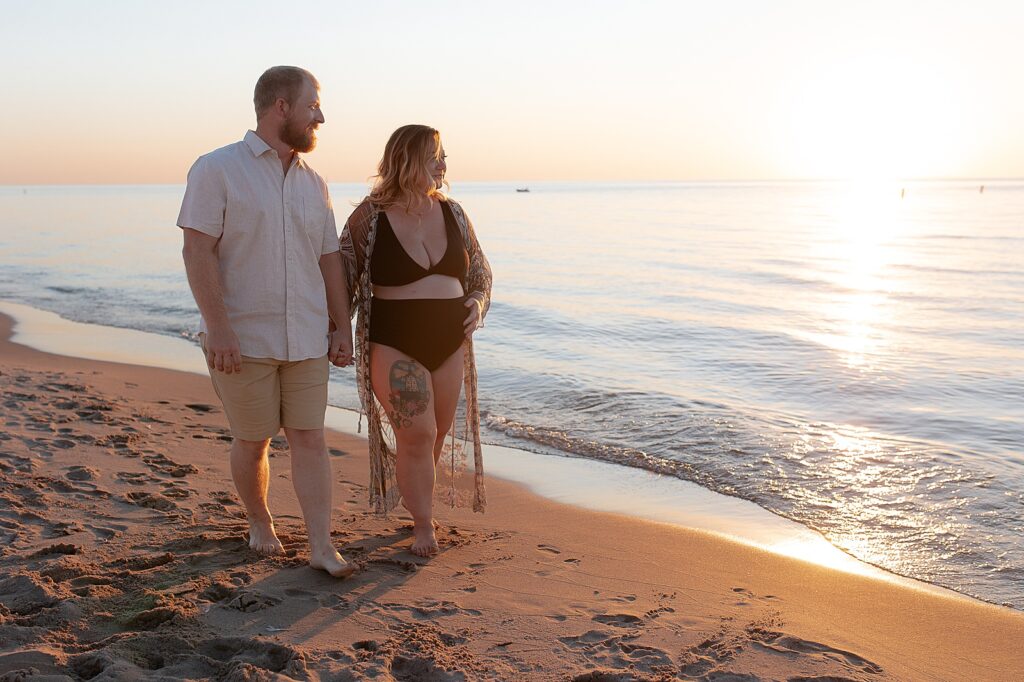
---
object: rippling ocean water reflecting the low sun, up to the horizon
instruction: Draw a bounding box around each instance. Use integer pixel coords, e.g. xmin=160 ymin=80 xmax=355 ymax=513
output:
xmin=0 ymin=181 xmax=1024 ymax=609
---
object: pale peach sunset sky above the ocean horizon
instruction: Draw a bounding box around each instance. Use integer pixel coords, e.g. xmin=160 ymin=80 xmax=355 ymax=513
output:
xmin=0 ymin=0 xmax=1024 ymax=184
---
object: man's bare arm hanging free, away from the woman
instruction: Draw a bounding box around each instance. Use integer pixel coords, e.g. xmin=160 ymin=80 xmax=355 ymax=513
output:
xmin=181 ymin=227 xmax=242 ymax=374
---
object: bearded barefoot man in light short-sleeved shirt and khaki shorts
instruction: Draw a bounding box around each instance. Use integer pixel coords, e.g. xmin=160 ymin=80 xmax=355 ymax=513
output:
xmin=178 ymin=67 xmax=353 ymax=578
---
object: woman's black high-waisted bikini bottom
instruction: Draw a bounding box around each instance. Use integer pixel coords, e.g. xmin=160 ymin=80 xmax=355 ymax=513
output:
xmin=370 ymin=296 xmax=469 ymax=372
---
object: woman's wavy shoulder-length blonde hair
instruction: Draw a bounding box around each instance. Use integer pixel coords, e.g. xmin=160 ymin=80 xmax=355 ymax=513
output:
xmin=370 ymin=124 xmax=447 ymax=212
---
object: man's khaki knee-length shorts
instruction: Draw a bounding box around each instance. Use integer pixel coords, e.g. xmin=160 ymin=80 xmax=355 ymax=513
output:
xmin=199 ymin=339 xmax=331 ymax=440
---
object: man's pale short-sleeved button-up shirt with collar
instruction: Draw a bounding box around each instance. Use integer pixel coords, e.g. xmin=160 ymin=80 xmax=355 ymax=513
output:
xmin=178 ymin=130 xmax=338 ymax=361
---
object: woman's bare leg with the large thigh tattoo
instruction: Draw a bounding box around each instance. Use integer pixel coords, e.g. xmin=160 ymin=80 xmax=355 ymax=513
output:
xmin=370 ymin=343 xmax=437 ymax=556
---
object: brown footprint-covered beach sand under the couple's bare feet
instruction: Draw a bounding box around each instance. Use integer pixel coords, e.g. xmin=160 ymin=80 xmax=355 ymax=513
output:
xmin=0 ymin=309 xmax=1024 ymax=681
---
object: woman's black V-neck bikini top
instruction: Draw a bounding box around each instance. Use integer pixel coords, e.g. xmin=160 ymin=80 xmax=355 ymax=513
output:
xmin=370 ymin=201 xmax=469 ymax=287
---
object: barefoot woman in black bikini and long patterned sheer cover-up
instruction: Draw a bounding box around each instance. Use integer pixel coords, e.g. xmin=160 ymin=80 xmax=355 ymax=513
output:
xmin=341 ymin=125 xmax=490 ymax=556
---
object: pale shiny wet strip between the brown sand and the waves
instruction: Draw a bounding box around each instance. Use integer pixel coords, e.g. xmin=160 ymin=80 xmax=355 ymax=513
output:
xmin=0 ymin=300 xmax=991 ymax=603
